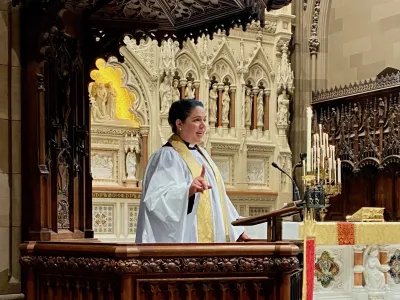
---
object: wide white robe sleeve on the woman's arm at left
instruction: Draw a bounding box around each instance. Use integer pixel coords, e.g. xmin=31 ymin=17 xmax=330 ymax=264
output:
xmin=140 ymin=147 xmax=192 ymax=243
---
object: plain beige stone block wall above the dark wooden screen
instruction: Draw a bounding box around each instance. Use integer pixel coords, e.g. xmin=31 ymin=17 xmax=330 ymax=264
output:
xmin=327 ymin=0 xmax=400 ymax=87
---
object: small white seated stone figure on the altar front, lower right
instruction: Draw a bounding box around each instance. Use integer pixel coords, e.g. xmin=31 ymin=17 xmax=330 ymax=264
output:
xmin=364 ymin=245 xmax=386 ymax=290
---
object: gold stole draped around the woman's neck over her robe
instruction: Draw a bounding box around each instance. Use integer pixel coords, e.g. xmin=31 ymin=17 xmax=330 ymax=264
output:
xmin=169 ymin=134 xmax=230 ymax=243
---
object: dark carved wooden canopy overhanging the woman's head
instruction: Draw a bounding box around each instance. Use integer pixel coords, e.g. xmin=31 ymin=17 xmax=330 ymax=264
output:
xmin=58 ymin=0 xmax=291 ymax=47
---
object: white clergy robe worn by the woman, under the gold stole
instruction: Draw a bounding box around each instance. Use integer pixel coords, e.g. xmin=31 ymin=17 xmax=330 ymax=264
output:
xmin=136 ymin=146 xmax=244 ymax=243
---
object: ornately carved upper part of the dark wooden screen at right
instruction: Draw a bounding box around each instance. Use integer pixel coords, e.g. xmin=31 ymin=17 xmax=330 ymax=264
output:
xmin=313 ymin=72 xmax=400 ymax=172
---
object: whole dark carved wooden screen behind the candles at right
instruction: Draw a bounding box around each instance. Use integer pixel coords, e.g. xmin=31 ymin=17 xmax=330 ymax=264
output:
xmin=313 ymin=69 xmax=400 ymax=220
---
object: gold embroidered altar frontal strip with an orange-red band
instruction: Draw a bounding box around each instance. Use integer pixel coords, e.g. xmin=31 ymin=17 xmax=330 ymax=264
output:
xmin=299 ymin=222 xmax=400 ymax=246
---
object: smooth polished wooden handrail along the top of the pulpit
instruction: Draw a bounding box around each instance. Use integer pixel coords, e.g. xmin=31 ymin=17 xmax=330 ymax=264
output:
xmin=20 ymin=241 xmax=299 ymax=258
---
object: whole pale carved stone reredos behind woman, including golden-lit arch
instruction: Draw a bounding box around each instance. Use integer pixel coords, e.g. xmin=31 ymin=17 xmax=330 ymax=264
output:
xmin=89 ymin=8 xmax=294 ymax=240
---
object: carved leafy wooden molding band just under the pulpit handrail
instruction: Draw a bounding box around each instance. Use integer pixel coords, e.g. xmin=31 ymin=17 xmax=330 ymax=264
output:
xmin=20 ymin=256 xmax=299 ymax=274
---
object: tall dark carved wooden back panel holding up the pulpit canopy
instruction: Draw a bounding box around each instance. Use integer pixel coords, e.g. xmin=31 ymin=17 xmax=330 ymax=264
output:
xmin=22 ymin=6 xmax=93 ymax=240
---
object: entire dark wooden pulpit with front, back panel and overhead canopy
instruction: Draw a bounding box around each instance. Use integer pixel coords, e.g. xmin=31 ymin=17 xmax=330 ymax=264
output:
xmin=17 ymin=0 xmax=301 ymax=300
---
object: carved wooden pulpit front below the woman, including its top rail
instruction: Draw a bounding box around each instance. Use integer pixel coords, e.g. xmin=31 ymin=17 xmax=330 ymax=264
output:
xmin=20 ymin=241 xmax=300 ymax=300
